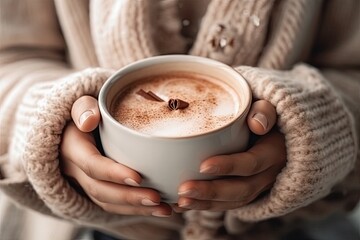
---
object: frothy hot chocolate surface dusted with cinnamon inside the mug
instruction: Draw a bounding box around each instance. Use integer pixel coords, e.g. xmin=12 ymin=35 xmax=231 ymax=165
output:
xmin=110 ymin=71 xmax=240 ymax=137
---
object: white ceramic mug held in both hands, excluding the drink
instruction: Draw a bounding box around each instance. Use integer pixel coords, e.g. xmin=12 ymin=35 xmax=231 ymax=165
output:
xmin=99 ymin=55 xmax=251 ymax=203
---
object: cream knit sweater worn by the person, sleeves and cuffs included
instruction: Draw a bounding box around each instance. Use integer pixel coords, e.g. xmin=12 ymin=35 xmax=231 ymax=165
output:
xmin=0 ymin=0 xmax=360 ymax=239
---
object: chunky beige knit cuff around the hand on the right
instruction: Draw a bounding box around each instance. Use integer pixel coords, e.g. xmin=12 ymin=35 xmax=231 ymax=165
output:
xmin=229 ymin=64 xmax=357 ymax=221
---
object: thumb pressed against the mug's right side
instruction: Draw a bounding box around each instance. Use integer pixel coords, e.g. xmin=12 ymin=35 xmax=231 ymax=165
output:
xmin=247 ymin=100 xmax=276 ymax=135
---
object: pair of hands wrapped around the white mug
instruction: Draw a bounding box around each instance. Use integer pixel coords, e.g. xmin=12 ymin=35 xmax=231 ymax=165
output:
xmin=61 ymin=96 xmax=286 ymax=217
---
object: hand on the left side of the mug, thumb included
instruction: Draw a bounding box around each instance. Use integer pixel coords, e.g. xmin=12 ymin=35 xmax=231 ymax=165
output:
xmin=60 ymin=96 xmax=172 ymax=217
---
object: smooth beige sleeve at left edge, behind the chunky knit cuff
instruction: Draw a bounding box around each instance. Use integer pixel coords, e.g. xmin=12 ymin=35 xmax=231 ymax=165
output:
xmin=0 ymin=0 xmax=71 ymax=213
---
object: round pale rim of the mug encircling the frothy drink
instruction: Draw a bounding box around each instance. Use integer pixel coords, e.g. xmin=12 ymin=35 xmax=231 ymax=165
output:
xmin=98 ymin=54 xmax=252 ymax=140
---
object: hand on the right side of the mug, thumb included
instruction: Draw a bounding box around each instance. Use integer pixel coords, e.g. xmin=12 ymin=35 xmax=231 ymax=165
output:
xmin=173 ymin=100 xmax=286 ymax=212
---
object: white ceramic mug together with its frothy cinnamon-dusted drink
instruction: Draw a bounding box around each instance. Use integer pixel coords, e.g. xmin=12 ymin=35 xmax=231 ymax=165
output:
xmin=99 ymin=55 xmax=251 ymax=203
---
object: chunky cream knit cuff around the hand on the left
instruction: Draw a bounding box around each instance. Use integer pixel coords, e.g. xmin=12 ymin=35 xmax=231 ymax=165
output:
xmin=10 ymin=69 xmax=128 ymax=223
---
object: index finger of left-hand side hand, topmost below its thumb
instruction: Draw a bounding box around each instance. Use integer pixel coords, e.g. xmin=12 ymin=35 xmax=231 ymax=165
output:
xmin=61 ymin=123 xmax=142 ymax=186
